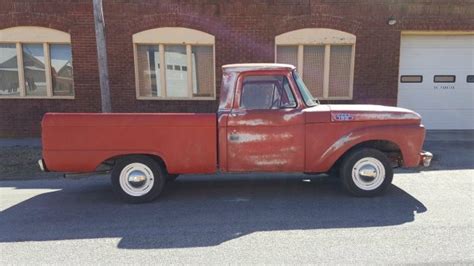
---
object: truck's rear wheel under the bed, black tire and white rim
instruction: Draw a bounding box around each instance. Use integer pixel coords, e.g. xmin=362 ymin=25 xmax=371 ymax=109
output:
xmin=111 ymin=155 xmax=165 ymax=203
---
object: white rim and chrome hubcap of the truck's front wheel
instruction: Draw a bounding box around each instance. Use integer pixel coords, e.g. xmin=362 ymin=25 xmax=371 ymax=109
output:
xmin=352 ymin=157 xmax=385 ymax=190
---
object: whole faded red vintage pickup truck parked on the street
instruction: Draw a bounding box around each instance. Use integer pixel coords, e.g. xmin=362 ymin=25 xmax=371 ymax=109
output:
xmin=39 ymin=64 xmax=432 ymax=202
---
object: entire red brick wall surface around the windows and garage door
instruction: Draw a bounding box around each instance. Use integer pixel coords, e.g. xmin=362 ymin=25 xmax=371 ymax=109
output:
xmin=0 ymin=0 xmax=474 ymax=136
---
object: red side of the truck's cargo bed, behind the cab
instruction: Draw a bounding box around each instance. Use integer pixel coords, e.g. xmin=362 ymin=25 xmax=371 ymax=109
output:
xmin=42 ymin=113 xmax=217 ymax=173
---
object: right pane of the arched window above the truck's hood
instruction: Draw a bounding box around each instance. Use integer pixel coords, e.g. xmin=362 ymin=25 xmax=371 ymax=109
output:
xmin=329 ymin=45 xmax=352 ymax=97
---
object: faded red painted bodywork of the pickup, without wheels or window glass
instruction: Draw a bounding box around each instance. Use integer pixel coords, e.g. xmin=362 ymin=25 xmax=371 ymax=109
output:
xmin=42 ymin=64 xmax=425 ymax=173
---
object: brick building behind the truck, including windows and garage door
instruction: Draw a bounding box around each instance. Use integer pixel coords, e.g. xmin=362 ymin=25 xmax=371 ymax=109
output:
xmin=0 ymin=0 xmax=474 ymax=137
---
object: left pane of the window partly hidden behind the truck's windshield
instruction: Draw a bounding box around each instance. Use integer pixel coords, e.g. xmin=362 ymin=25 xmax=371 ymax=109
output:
xmin=303 ymin=45 xmax=325 ymax=97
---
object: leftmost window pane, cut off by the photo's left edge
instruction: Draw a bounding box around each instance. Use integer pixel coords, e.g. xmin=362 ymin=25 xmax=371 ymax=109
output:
xmin=0 ymin=44 xmax=20 ymax=96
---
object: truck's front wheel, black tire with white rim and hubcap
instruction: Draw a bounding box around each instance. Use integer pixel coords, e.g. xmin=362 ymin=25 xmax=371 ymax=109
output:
xmin=340 ymin=148 xmax=393 ymax=197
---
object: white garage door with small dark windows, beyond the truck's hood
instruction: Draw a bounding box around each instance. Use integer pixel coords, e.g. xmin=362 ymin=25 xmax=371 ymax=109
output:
xmin=398 ymin=35 xmax=474 ymax=129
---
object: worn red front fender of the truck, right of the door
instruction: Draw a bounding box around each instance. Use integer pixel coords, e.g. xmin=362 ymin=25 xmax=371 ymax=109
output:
xmin=306 ymin=121 xmax=425 ymax=172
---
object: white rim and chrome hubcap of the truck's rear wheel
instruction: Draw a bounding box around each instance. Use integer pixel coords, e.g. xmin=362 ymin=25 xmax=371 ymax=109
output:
xmin=120 ymin=163 xmax=155 ymax=197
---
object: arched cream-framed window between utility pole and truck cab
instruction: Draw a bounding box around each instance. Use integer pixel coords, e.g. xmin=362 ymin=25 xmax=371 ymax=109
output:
xmin=133 ymin=27 xmax=216 ymax=100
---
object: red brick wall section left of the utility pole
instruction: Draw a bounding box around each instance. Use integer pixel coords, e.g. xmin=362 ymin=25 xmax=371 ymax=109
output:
xmin=0 ymin=0 xmax=100 ymax=137
